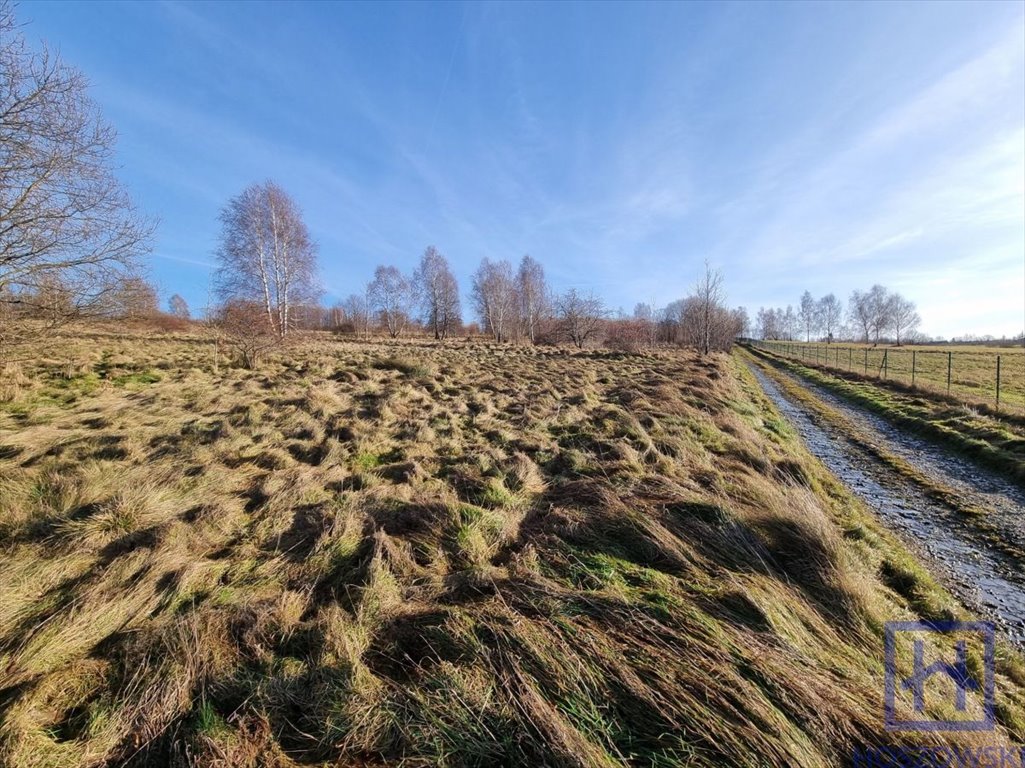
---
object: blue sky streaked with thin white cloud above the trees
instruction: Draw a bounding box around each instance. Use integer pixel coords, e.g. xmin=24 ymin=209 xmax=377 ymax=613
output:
xmin=17 ymin=2 xmax=1025 ymax=336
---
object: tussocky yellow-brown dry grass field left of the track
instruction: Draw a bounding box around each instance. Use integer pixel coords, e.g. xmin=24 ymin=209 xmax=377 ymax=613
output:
xmin=0 ymin=332 xmax=1025 ymax=766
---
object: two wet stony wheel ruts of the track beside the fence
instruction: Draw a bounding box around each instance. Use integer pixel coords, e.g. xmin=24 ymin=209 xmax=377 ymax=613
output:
xmin=751 ymin=366 xmax=1025 ymax=647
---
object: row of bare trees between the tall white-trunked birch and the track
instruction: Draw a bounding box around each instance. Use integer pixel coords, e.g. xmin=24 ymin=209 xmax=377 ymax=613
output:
xmin=310 ymin=256 xmax=748 ymax=353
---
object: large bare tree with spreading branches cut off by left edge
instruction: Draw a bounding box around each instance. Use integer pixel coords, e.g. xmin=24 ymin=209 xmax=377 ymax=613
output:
xmin=0 ymin=2 xmax=153 ymax=355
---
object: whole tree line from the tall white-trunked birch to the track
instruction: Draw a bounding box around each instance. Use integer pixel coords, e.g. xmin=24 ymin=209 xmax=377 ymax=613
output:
xmin=211 ymin=181 xmax=747 ymax=365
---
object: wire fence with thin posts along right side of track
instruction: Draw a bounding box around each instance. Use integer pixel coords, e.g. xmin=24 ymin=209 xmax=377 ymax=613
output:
xmin=750 ymin=339 xmax=1025 ymax=412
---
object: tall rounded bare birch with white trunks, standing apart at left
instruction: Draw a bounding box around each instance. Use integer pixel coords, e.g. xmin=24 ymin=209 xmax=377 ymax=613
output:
xmin=215 ymin=181 xmax=319 ymax=339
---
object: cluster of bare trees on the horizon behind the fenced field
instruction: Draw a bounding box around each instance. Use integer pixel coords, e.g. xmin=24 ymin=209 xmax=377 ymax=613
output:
xmin=755 ymin=284 xmax=921 ymax=346
